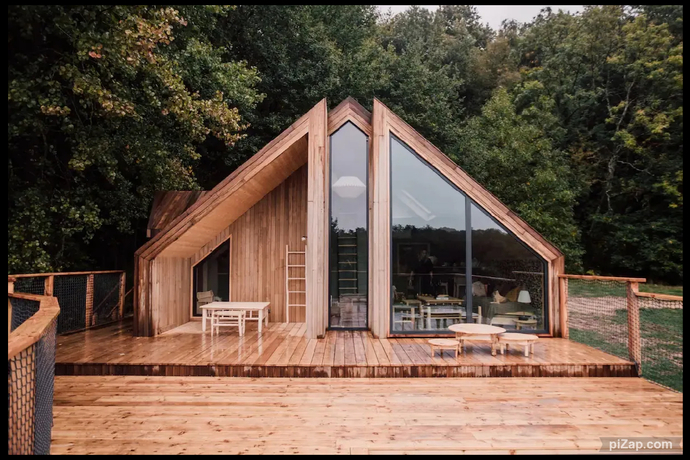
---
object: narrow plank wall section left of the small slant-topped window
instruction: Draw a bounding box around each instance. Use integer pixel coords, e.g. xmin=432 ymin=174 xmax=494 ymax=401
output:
xmin=151 ymin=256 xmax=191 ymax=334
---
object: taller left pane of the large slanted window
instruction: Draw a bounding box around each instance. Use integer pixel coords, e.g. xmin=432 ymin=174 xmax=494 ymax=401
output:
xmin=391 ymin=137 xmax=466 ymax=332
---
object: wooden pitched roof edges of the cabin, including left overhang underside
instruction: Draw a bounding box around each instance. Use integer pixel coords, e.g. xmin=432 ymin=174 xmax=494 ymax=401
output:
xmin=135 ymin=97 xmax=562 ymax=260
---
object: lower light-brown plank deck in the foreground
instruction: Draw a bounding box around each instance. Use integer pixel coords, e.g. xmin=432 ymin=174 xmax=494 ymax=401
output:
xmin=51 ymin=376 xmax=683 ymax=454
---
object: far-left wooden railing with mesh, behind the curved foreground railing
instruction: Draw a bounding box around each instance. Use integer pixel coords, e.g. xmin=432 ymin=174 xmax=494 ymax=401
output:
xmin=8 ymin=270 xmax=125 ymax=333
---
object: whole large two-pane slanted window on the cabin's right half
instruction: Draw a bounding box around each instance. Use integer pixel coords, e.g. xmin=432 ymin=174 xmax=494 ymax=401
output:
xmin=390 ymin=136 xmax=547 ymax=333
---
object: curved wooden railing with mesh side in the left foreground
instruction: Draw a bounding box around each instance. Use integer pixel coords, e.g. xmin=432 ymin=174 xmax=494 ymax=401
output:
xmin=7 ymin=292 xmax=60 ymax=455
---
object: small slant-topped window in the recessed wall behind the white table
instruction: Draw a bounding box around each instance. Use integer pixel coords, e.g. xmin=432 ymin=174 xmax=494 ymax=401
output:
xmin=192 ymin=240 xmax=230 ymax=316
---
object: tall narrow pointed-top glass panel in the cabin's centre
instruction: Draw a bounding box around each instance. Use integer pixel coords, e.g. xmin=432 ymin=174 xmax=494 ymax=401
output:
xmin=328 ymin=122 xmax=369 ymax=329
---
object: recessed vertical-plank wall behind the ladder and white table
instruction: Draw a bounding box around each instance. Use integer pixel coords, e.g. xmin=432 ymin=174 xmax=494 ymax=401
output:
xmin=187 ymin=165 xmax=308 ymax=322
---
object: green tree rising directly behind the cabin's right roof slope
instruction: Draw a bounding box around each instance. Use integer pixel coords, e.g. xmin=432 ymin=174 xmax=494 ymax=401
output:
xmin=452 ymin=88 xmax=582 ymax=270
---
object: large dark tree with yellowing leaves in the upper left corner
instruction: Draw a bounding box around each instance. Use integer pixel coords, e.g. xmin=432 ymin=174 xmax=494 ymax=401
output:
xmin=8 ymin=6 xmax=261 ymax=272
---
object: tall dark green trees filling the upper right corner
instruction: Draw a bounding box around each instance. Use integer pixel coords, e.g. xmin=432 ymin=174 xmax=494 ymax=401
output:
xmin=516 ymin=6 xmax=683 ymax=282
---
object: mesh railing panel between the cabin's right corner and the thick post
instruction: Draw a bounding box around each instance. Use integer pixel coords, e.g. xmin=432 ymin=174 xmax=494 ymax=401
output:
xmin=565 ymin=279 xmax=629 ymax=359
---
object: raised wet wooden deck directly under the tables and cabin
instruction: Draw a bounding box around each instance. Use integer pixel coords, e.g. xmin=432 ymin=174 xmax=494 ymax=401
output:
xmin=56 ymin=321 xmax=636 ymax=377
